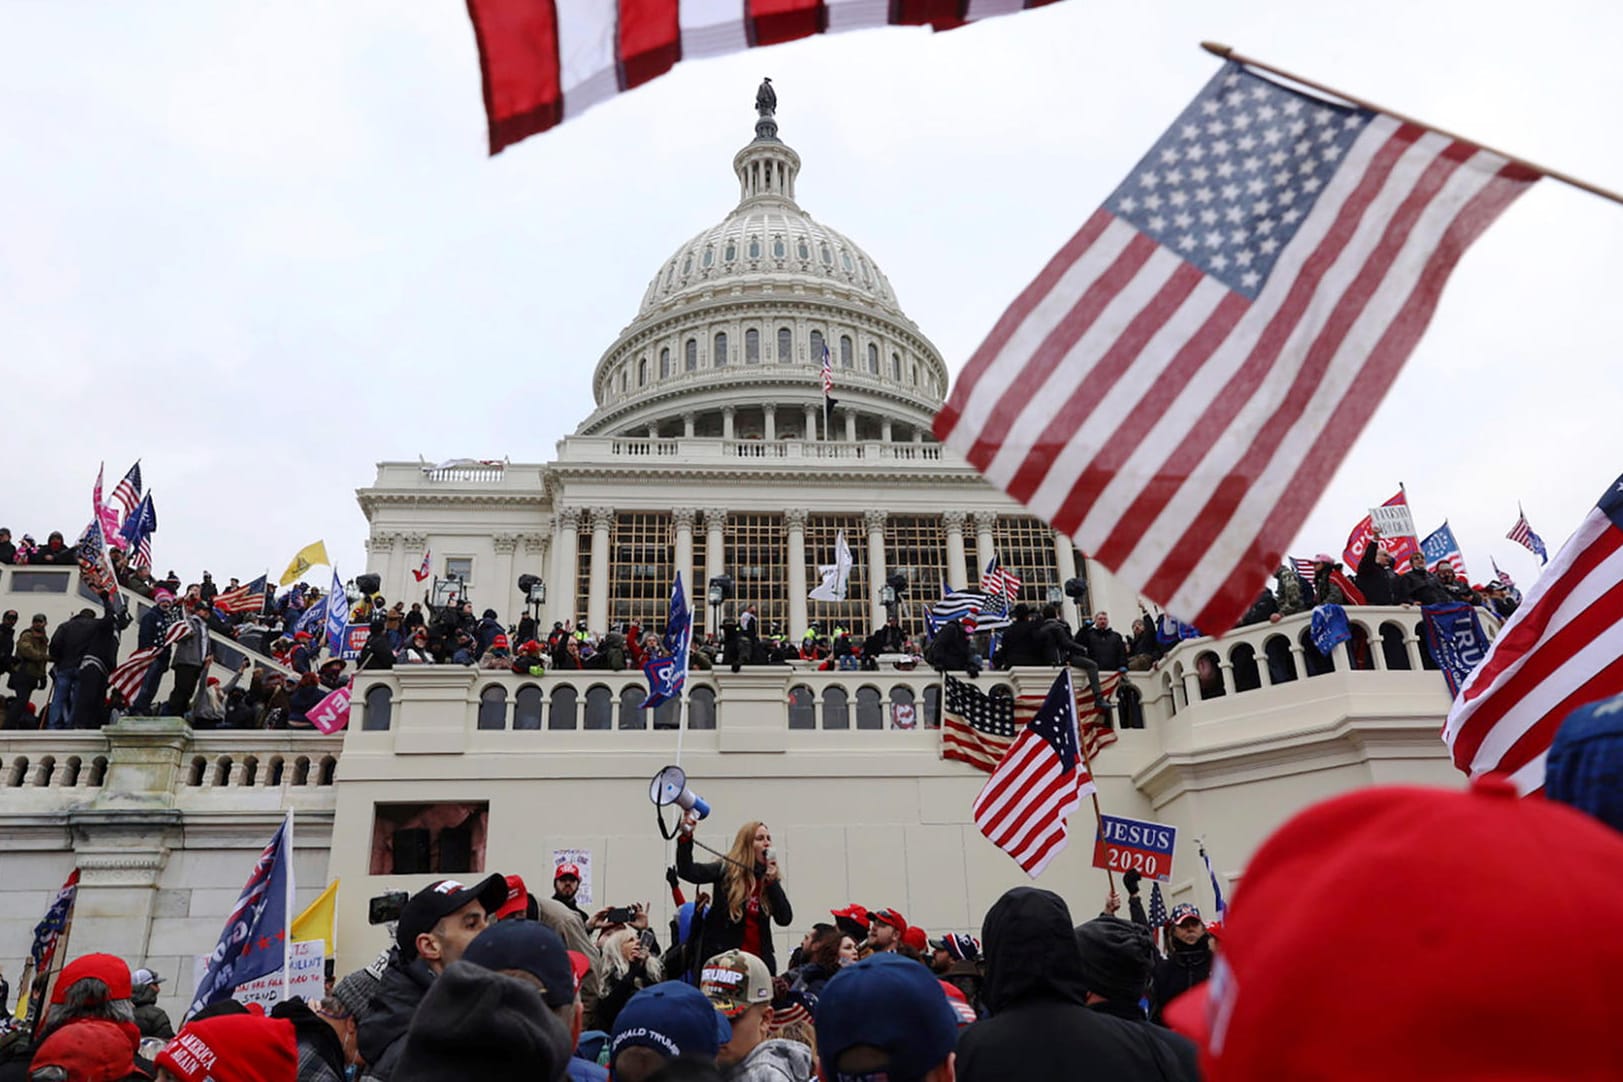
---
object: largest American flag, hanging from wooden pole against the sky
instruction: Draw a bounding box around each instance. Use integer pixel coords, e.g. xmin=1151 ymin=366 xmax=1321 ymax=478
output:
xmin=935 ymin=63 xmax=1537 ymax=634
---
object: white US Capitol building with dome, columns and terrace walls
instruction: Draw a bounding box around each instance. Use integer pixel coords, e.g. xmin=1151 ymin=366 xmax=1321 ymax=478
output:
xmin=0 ymin=86 xmax=1461 ymax=1012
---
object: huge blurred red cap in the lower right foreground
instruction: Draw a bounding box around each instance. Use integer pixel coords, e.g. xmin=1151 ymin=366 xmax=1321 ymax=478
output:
xmin=1165 ymin=779 xmax=1623 ymax=1082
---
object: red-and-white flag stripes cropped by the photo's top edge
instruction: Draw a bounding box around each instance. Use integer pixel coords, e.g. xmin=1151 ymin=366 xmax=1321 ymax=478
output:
xmin=467 ymin=0 xmax=1052 ymax=154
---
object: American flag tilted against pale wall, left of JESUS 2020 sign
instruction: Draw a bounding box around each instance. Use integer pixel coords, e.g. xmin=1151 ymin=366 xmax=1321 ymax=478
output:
xmin=972 ymin=668 xmax=1094 ymax=879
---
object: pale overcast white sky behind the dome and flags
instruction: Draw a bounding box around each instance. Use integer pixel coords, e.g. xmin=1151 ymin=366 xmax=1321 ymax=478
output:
xmin=0 ymin=0 xmax=1623 ymax=596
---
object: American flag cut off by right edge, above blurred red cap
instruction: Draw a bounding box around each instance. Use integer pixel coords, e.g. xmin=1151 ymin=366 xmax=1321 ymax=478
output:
xmin=1443 ymin=477 xmax=1623 ymax=793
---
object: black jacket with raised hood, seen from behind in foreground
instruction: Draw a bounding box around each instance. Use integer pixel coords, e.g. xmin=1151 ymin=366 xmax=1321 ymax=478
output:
xmin=958 ymin=887 xmax=1191 ymax=1082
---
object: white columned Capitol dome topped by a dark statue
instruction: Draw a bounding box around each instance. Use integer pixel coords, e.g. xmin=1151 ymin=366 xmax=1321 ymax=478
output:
xmin=578 ymin=90 xmax=948 ymax=441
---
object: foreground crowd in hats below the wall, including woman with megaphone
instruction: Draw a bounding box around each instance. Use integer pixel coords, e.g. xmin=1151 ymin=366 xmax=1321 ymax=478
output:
xmin=12 ymin=736 xmax=1623 ymax=1082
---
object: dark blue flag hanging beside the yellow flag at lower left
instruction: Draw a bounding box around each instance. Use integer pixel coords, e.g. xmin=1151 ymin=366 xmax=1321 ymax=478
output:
xmin=187 ymin=811 xmax=294 ymax=1017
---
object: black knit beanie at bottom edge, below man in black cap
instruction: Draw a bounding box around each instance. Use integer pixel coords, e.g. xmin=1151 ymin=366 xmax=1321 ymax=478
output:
xmin=393 ymin=962 xmax=570 ymax=1082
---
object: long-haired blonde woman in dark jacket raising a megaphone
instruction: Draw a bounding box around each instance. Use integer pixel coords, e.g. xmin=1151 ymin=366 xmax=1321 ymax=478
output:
xmin=677 ymin=811 xmax=795 ymax=973
